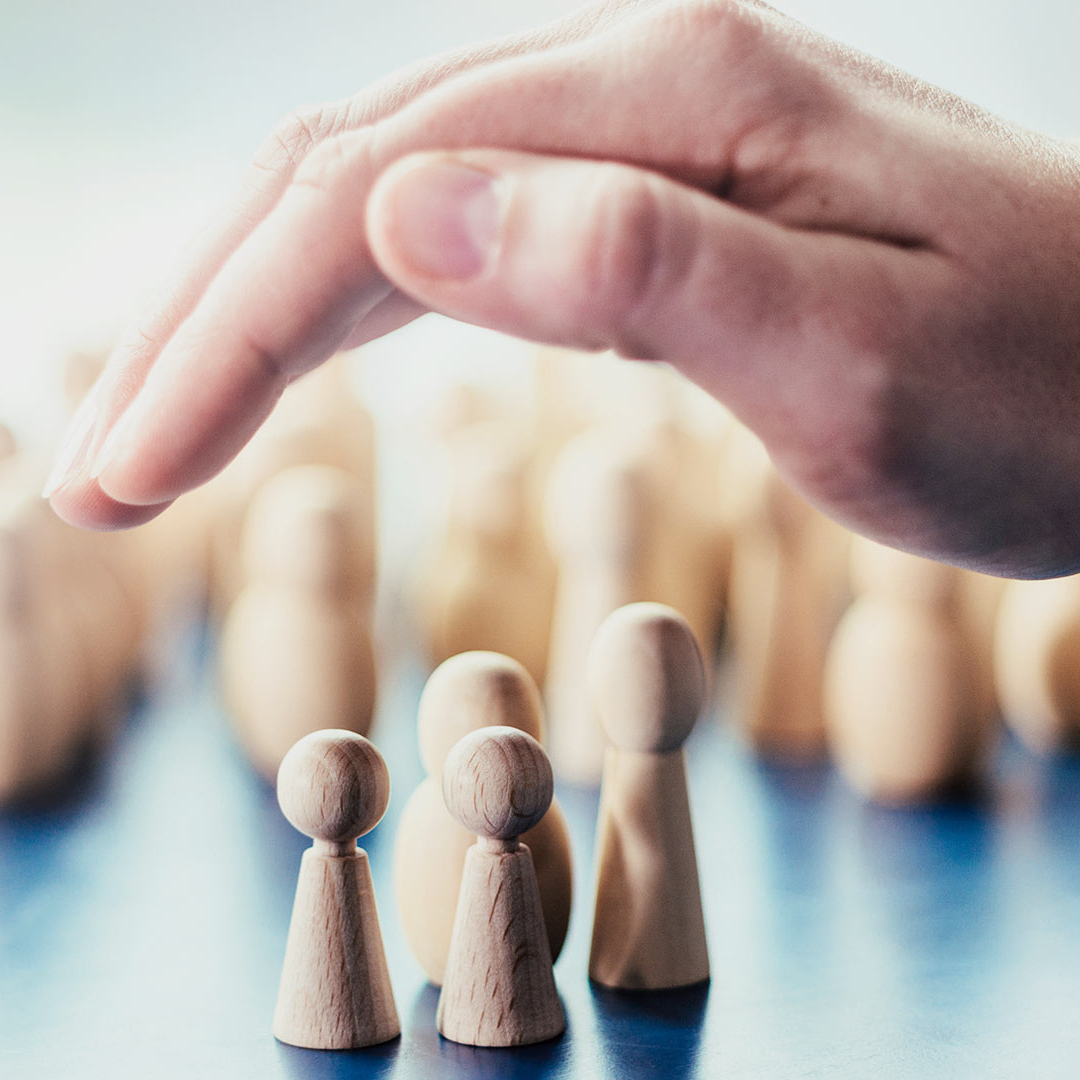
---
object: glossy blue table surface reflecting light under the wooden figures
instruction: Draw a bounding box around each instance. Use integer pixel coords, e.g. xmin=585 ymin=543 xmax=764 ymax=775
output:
xmin=0 ymin=635 xmax=1080 ymax=1080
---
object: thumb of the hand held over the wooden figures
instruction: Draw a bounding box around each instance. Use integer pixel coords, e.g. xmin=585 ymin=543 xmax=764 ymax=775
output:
xmin=367 ymin=150 xmax=809 ymax=419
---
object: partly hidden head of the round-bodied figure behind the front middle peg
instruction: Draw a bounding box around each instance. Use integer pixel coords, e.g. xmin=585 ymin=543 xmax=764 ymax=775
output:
xmin=417 ymin=650 xmax=543 ymax=777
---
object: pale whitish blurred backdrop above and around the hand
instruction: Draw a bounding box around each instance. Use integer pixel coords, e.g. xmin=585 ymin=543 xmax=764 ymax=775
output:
xmin=0 ymin=0 xmax=1080 ymax=445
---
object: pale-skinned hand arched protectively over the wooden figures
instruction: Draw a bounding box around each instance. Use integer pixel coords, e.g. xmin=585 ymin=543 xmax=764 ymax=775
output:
xmin=44 ymin=0 xmax=1080 ymax=577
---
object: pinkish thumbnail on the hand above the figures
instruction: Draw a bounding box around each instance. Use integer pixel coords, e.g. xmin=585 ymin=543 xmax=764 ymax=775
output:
xmin=391 ymin=158 xmax=502 ymax=278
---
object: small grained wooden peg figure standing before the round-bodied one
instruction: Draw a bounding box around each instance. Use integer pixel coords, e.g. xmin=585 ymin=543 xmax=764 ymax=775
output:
xmin=436 ymin=727 xmax=566 ymax=1047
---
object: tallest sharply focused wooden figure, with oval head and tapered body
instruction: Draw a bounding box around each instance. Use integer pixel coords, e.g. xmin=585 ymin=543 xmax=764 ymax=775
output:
xmin=589 ymin=604 xmax=708 ymax=990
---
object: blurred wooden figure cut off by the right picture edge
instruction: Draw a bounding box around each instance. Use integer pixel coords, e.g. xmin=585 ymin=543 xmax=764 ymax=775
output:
xmin=994 ymin=576 xmax=1080 ymax=754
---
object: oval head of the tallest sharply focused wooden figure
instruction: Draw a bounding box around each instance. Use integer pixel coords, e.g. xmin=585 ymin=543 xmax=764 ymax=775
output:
xmin=586 ymin=604 xmax=705 ymax=753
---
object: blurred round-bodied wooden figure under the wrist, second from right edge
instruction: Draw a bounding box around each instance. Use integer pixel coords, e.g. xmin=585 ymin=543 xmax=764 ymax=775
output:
xmin=825 ymin=538 xmax=995 ymax=802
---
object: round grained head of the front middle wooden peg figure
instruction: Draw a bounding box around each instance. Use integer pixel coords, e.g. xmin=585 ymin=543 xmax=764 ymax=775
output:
xmin=443 ymin=727 xmax=554 ymax=840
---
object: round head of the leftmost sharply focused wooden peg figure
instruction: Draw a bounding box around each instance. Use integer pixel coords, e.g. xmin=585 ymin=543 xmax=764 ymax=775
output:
xmin=278 ymin=729 xmax=390 ymax=843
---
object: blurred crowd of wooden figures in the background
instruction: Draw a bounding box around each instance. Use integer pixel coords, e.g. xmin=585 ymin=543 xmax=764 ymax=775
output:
xmin=10 ymin=336 xmax=1080 ymax=801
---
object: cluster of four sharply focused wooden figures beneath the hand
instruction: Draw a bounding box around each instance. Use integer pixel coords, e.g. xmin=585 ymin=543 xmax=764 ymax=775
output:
xmin=273 ymin=604 xmax=708 ymax=1050
